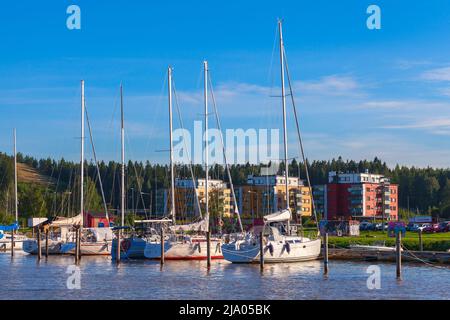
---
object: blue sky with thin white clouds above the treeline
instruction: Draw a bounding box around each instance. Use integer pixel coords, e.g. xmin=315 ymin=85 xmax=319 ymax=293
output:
xmin=0 ymin=0 xmax=450 ymax=168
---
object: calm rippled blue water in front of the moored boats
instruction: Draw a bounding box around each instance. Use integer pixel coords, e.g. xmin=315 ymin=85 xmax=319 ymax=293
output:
xmin=0 ymin=254 xmax=450 ymax=300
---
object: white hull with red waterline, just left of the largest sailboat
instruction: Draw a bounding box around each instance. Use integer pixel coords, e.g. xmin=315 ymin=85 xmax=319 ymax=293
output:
xmin=144 ymin=240 xmax=223 ymax=260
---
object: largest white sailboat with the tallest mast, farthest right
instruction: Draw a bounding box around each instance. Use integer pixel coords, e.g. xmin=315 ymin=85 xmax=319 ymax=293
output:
xmin=222 ymin=20 xmax=321 ymax=263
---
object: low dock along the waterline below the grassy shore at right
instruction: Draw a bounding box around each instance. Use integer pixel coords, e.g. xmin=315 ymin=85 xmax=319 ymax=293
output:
xmin=329 ymin=248 xmax=450 ymax=265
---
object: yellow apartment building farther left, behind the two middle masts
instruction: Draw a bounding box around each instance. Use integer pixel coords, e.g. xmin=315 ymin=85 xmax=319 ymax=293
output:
xmin=175 ymin=179 xmax=234 ymax=220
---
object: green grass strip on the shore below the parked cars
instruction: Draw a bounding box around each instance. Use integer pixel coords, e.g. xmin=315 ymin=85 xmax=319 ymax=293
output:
xmin=328 ymin=231 xmax=450 ymax=251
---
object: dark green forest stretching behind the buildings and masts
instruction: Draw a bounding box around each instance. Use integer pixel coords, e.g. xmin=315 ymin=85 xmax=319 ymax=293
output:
xmin=0 ymin=153 xmax=450 ymax=223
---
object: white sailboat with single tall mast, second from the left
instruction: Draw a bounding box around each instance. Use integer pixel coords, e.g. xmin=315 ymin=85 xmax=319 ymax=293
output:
xmin=61 ymin=80 xmax=113 ymax=255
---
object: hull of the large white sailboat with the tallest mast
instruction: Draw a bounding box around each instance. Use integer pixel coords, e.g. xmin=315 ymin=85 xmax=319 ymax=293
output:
xmin=222 ymin=239 xmax=321 ymax=263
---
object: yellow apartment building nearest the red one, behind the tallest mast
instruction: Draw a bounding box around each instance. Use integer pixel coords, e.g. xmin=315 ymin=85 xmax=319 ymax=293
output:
xmin=236 ymin=175 xmax=312 ymax=218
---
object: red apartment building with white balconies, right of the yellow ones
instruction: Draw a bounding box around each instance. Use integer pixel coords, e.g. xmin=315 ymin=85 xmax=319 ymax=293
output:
xmin=324 ymin=171 xmax=398 ymax=220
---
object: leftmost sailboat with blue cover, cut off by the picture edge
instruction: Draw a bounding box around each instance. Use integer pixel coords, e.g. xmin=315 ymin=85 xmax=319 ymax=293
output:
xmin=0 ymin=129 xmax=28 ymax=251
